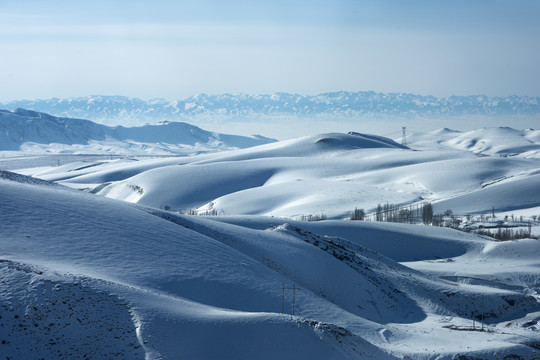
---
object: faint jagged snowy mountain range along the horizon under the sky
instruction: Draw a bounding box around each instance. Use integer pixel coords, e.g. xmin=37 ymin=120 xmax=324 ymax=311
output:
xmin=0 ymin=91 xmax=540 ymax=125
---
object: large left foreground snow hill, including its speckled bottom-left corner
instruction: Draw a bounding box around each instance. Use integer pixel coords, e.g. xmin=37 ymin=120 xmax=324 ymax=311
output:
xmin=0 ymin=176 xmax=389 ymax=359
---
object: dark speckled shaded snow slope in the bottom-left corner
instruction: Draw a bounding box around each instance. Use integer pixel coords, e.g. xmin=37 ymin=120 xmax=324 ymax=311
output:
xmin=0 ymin=260 xmax=144 ymax=359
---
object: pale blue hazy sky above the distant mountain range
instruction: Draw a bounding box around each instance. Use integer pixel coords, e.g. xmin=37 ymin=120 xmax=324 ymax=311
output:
xmin=0 ymin=0 xmax=540 ymax=101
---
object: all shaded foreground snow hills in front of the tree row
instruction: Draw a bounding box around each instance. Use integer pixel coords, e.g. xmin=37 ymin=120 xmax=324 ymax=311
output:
xmin=0 ymin=171 xmax=540 ymax=359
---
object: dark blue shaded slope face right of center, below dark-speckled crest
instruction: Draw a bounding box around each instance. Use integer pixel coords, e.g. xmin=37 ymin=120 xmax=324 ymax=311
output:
xmin=155 ymin=215 xmax=425 ymax=323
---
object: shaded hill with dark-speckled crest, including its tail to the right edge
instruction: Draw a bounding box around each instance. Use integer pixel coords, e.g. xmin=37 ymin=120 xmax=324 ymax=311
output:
xmin=154 ymin=213 xmax=538 ymax=324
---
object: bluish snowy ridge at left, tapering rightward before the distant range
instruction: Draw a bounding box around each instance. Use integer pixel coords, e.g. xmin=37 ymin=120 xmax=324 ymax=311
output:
xmin=0 ymin=109 xmax=274 ymax=155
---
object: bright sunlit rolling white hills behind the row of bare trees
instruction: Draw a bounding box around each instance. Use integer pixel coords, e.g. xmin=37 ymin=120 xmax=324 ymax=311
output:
xmin=17 ymin=129 xmax=540 ymax=219
